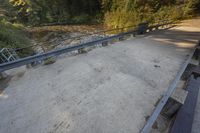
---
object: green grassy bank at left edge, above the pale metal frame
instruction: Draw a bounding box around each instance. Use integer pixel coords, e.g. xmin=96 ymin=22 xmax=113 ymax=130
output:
xmin=0 ymin=20 xmax=33 ymax=57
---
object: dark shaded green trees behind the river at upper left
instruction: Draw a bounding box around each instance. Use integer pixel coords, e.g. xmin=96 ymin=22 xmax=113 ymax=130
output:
xmin=9 ymin=0 xmax=100 ymax=25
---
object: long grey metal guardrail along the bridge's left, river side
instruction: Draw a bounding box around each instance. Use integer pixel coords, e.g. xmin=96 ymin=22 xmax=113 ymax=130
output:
xmin=0 ymin=22 xmax=172 ymax=73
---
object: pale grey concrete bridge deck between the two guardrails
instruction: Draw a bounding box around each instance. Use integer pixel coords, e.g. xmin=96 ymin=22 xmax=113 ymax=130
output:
xmin=0 ymin=20 xmax=200 ymax=133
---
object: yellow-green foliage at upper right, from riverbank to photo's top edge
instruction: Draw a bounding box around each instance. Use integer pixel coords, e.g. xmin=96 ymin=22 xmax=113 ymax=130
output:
xmin=102 ymin=0 xmax=200 ymax=28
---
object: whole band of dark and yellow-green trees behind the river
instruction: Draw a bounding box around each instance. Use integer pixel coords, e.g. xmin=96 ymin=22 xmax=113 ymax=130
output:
xmin=0 ymin=0 xmax=200 ymax=27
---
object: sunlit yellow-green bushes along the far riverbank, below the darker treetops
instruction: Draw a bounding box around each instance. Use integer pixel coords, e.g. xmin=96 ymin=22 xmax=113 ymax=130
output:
xmin=104 ymin=0 xmax=197 ymax=28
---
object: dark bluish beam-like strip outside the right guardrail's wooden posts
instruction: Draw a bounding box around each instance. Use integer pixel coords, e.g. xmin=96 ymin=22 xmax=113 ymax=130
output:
xmin=170 ymin=77 xmax=200 ymax=133
